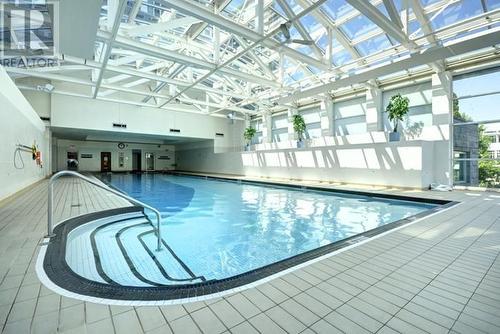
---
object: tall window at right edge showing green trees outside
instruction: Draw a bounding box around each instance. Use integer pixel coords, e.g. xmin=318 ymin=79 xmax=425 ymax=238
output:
xmin=453 ymin=69 xmax=500 ymax=188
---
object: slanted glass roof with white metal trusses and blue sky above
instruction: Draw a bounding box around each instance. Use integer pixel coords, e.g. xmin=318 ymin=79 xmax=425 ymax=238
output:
xmin=5 ymin=0 xmax=500 ymax=114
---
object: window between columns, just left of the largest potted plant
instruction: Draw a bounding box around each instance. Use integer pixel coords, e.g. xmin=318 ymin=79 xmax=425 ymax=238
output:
xmin=333 ymin=97 xmax=366 ymax=136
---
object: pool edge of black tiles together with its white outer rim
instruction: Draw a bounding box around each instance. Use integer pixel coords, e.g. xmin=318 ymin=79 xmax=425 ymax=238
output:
xmin=37 ymin=180 xmax=459 ymax=305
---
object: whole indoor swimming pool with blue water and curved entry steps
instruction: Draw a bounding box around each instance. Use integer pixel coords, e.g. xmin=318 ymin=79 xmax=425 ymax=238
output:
xmin=39 ymin=174 xmax=450 ymax=299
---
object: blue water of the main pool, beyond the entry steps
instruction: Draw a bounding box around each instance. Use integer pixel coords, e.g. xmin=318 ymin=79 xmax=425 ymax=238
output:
xmin=94 ymin=174 xmax=435 ymax=280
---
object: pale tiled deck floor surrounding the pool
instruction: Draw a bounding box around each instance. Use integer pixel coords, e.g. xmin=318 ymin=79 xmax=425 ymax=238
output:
xmin=0 ymin=178 xmax=500 ymax=334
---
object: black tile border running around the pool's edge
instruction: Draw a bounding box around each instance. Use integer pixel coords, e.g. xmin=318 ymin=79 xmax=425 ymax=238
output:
xmin=43 ymin=175 xmax=459 ymax=301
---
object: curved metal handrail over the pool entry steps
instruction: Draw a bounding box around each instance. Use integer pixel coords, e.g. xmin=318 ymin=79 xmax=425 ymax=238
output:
xmin=46 ymin=170 xmax=161 ymax=251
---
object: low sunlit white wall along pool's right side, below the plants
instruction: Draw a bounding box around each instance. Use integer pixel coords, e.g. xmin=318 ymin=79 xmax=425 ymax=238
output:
xmin=176 ymin=132 xmax=444 ymax=188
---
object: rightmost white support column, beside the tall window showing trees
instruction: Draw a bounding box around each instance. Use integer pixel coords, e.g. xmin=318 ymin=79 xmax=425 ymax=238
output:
xmin=432 ymin=71 xmax=453 ymax=186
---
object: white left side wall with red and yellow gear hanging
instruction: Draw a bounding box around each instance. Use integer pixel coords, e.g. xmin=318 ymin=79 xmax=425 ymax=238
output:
xmin=0 ymin=66 xmax=50 ymax=200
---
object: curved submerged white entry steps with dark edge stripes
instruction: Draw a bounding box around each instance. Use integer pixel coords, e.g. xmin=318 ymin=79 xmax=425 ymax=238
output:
xmin=66 ymin=211 xmax=204 ymax=287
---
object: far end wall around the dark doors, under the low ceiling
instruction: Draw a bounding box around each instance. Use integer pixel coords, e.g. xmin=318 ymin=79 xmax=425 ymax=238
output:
xmin=56 ymin=139 xmax=175 ymax=172
